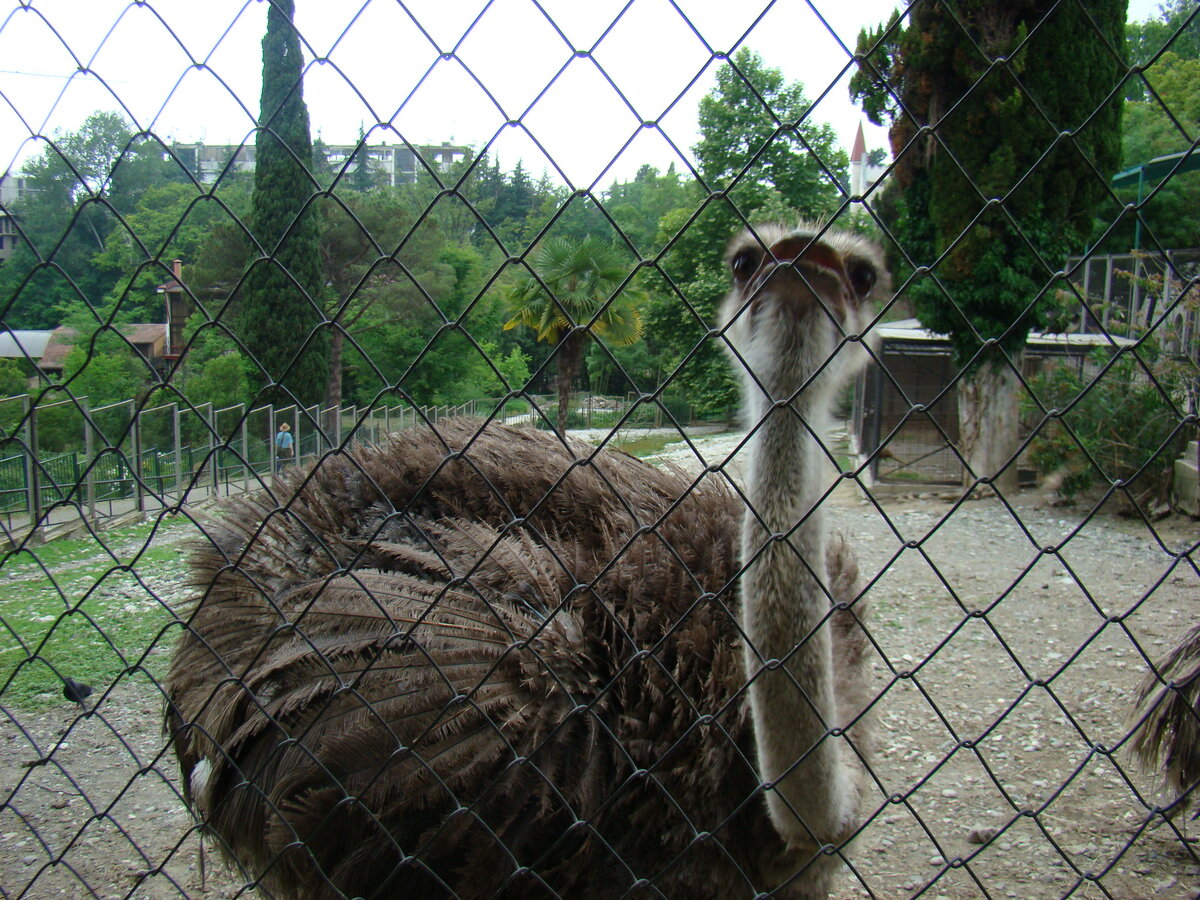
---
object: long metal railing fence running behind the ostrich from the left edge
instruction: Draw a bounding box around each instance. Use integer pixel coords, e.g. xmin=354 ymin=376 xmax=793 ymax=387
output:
xmin=0 ymin=395 xmax=689 ymax=535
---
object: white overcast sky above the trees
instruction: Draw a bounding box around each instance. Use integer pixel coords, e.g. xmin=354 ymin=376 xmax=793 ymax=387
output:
xmin=0 ymin=0 xmax=1158 ymax=188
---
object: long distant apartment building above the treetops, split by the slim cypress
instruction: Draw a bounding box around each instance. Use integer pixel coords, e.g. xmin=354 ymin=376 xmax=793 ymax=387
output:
xmin=172 ymin=142 xmax=470 ymax=186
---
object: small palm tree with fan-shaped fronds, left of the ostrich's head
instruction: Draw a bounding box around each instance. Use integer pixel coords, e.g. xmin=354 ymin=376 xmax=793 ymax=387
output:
xmin=504 ymin=235 xmax=646 ymax=433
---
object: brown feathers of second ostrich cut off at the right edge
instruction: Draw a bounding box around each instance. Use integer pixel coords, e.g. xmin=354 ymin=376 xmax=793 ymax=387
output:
xmin=1133 ymin=625 xmax=1200 ymax=816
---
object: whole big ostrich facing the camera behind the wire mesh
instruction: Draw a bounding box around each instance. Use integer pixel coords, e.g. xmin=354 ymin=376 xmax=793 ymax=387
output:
xmin=167 ymin=224 xmax=886 ymax=900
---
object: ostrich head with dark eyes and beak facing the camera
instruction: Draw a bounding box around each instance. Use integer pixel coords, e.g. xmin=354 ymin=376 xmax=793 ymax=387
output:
xmin=720 ymin=222 xmax=888 ymax=414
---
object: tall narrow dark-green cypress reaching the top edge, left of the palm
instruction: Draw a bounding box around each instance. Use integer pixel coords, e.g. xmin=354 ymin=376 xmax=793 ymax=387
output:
xmin=240 ymin=0 xmax=329 ymax=404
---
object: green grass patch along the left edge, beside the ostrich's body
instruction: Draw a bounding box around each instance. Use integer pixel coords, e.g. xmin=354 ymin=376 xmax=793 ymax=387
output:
xmin=0 ymin=522 xmax=196 ymax=709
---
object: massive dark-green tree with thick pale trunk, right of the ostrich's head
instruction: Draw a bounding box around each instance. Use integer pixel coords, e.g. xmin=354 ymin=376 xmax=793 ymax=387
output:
xmin=851 ymin=0 xmax=1126 ymax=494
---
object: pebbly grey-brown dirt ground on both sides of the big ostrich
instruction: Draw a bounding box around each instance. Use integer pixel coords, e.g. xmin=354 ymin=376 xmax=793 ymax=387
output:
xmin=0 ymin=440 xmax=1200 ymax=900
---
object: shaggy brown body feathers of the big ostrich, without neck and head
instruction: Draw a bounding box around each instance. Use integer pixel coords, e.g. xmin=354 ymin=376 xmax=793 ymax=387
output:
xmin=168 ymin=420 xmax=864 ymax=899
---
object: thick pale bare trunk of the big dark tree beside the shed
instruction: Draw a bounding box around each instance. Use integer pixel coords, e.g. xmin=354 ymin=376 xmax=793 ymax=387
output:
xmin=958 ymin=356 xmax=1022 ymax=492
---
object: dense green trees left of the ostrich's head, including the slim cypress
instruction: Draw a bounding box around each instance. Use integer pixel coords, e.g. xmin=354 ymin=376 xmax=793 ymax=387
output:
xmin=0 ymin=44 xmax=888 ymax=432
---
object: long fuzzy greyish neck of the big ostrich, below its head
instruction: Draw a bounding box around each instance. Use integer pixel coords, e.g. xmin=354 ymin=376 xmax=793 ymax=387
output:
xmin=742 ymin=403 xmax=852 ymax=846
